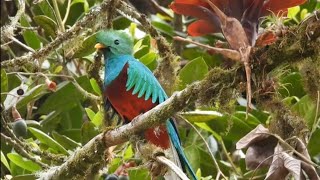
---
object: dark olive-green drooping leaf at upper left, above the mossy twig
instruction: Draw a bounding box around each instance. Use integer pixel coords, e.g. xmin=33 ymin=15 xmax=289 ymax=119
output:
xmin=33 ymin=15 xmax=57 ymax=38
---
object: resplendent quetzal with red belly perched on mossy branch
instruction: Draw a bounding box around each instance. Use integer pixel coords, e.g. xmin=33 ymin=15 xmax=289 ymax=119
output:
xmin=95 ymin=30 xmax=196 ymax=179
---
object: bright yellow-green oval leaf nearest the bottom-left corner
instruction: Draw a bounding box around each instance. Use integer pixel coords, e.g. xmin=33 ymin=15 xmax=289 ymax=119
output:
xmin=7 ymin=153 xmax=41 ymax=172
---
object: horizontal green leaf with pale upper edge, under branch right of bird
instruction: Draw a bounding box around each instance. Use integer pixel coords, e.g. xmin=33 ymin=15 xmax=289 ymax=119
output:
xmin=181 ymin=110 xmax=222 ymax=122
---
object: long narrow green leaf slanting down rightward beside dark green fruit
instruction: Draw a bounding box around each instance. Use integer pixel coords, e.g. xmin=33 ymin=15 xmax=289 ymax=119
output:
xmin=28 ymin=127 xmax=68 ymax=155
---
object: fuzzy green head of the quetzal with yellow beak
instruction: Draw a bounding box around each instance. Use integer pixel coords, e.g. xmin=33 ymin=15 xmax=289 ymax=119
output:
xmin=95 ymin=30 xmax=133 ymax=57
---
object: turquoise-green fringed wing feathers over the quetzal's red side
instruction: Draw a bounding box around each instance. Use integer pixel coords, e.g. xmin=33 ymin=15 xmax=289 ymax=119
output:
xmin=126 ymin=58 xmax=168 ymax=103
